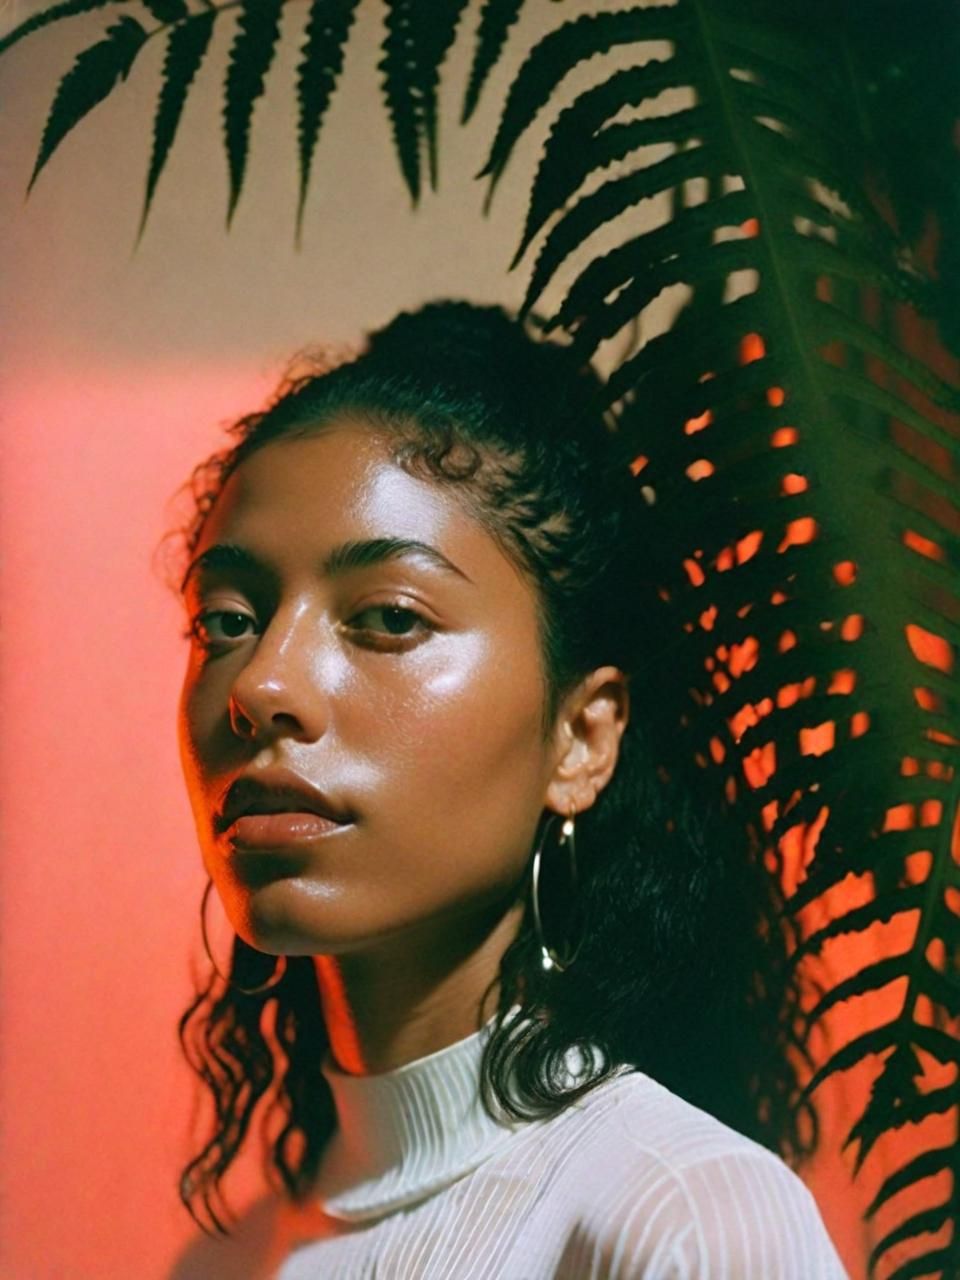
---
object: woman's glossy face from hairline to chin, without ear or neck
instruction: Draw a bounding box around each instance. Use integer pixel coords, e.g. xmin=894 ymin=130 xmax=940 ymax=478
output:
xmin=178 ymin=419 xmax=556 ymax=955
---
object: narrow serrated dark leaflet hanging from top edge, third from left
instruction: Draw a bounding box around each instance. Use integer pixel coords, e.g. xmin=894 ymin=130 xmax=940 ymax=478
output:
xmin=223 ymin=0 xmax=284 ymax=227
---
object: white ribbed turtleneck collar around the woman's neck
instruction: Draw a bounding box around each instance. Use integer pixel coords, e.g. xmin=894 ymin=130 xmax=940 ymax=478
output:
xmin=315 ymin=1006 xmax=586 ymax=1222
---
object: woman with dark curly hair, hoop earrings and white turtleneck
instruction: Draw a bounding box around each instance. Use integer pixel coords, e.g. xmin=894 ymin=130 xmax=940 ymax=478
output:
xmin=167 ymin=302 xmax=845 ymax=1280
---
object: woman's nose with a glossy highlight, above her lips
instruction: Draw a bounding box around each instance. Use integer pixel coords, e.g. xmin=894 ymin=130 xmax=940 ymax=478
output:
xmin=228 ymin=604 xmax=329 ymax=742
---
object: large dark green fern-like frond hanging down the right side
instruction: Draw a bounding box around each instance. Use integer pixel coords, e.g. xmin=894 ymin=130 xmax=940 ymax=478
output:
xmin=483 ymin=0 xmax=960 ymax=1274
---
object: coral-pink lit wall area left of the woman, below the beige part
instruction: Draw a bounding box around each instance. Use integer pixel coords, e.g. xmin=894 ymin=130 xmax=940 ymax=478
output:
xmin=0 ymin=366 xmax=281 ymax=1280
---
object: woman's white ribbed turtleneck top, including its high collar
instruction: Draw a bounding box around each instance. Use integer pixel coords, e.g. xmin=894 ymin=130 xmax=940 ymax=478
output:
xmin=263 ymin=1023 xmax=849 ymax=1280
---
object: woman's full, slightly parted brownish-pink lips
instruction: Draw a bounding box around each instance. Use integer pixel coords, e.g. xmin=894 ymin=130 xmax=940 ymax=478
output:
xmin=215 ymin=768 xmax=353 ymax=842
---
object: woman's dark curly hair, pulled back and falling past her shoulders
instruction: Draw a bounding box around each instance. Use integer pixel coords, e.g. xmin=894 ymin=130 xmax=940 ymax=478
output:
xmin=168 ymin=301 xmax=818 ymax=1231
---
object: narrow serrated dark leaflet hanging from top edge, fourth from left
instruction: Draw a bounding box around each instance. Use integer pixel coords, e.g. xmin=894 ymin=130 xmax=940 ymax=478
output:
xmin=297 ymin=0 xmax=358 ymax=242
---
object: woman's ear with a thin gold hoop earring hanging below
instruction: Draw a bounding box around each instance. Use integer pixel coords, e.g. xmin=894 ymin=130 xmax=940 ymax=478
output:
xmin=544 ymin=667 xmax=630 ymax=815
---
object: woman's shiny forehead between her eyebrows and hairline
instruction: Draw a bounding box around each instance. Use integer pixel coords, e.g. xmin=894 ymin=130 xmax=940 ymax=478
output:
xmin=196 ymin=419 xmax=521 ymax=581
